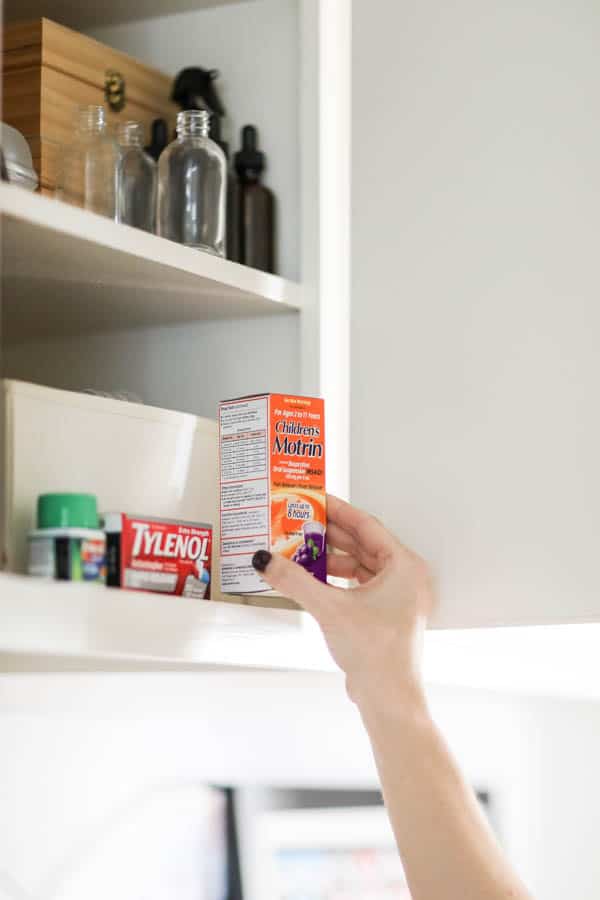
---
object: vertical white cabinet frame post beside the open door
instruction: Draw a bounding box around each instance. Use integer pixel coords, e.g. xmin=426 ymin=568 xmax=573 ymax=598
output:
xmin=299 ymin=0 xmax=351 ymax=497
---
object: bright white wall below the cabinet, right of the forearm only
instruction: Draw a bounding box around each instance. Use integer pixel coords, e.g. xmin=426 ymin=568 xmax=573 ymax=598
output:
xmin=433 ymin=690 xmax=600 ymax=900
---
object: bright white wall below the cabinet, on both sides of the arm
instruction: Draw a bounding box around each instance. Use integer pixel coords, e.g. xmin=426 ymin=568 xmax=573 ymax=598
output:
xmin=0 ymin=673 xmax=600 ymax=900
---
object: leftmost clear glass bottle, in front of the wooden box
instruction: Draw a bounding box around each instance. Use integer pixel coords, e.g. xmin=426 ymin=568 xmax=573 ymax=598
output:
xmin=56 ymin=106 xmax=121 ymax=219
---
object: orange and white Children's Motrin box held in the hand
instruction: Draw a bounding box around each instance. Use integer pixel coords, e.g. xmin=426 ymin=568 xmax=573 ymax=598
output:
xmin=219 ymin=394 xmax=327 ymax=594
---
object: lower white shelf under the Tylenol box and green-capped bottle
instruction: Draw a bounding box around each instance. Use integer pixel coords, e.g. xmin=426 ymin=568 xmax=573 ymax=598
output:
xmin=0 ymin=574 xmax=333 ymax=671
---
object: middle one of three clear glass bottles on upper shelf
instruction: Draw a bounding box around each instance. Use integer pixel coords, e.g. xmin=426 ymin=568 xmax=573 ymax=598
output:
xmin=117 ymin=122 xmax=156 ymax=231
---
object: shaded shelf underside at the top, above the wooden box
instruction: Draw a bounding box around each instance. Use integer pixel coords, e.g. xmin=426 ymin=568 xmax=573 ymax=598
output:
xmin=4 ymin=0 xmax=248 ymax=30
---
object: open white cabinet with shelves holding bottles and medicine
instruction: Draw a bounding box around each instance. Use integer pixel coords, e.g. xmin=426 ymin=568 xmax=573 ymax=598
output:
xmin=0 ymin=0 xmax=349 ymax=669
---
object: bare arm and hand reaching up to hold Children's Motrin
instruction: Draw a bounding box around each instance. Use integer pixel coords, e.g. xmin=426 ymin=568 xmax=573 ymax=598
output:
xmin=255 ymin=497 xmax=530 ymax=900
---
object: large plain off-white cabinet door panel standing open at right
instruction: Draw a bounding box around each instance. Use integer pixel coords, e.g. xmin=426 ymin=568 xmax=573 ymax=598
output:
xmin=351 ymin=0 xmax=600 ymax=624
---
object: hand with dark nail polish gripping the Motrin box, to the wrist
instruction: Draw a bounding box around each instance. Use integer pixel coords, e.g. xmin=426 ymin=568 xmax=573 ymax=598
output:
xmin=253 ymin=496 xmax=433 ymax=705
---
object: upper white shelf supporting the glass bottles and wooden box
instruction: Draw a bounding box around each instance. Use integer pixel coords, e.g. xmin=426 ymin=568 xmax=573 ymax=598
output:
xmin=0 ymin=184 xmax=300 ymax=344
